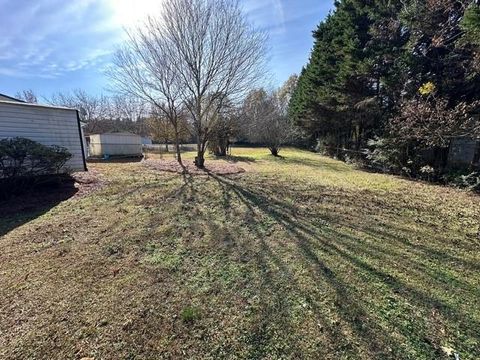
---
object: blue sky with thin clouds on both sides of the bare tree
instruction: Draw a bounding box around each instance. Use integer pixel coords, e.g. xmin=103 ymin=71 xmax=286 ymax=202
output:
xmin=0 ymin=0 xmax=333 ymax=96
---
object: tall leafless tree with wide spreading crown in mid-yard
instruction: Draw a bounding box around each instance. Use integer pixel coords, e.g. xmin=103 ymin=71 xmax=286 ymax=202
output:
xmin=141 ymin=0 xmax=266 ymax=168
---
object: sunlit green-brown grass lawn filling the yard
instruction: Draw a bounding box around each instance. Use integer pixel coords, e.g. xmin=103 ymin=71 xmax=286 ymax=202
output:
xmin=0 ymin=148 xmax=480 ymax=360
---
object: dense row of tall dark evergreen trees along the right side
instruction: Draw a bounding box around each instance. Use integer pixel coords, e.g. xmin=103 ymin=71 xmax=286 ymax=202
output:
xmin=288 ymin=0 xmax=480 ymax=180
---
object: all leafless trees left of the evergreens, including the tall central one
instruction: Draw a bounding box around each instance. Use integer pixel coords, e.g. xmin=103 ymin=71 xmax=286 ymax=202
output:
xmin=14 ymin=0 xmax=304 ymax=167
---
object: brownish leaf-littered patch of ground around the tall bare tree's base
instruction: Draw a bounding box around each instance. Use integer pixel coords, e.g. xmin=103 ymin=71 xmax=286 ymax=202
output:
xmin=144 ymin=160 xmax=245 ymax=175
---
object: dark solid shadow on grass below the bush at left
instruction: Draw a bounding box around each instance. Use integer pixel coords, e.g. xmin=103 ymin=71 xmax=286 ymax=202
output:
xmin=0 ymin=177 xmax=78 ymax=236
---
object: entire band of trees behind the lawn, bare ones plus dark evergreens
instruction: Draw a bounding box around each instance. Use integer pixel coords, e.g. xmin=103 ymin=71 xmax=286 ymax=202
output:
xmin=13 ymin=0 xmax=480 ymax=187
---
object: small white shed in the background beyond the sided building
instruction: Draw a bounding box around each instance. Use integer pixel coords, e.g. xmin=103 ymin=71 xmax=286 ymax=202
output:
xmin=88 ymin=132 xmax=142 ymax=157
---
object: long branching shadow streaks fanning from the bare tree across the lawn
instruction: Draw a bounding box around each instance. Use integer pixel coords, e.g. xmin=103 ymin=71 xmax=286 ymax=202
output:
xmin=208 ymin=175 xmax=480 ymax=358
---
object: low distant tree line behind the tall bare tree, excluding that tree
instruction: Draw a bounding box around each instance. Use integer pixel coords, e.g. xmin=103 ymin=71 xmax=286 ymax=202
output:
xmin=15 ymin=75 xmax=300 ymax=156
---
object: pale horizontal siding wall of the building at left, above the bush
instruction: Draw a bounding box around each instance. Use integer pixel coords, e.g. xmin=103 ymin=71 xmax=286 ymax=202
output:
xmin=0 ymin=101 xmax=85 ymax=171
